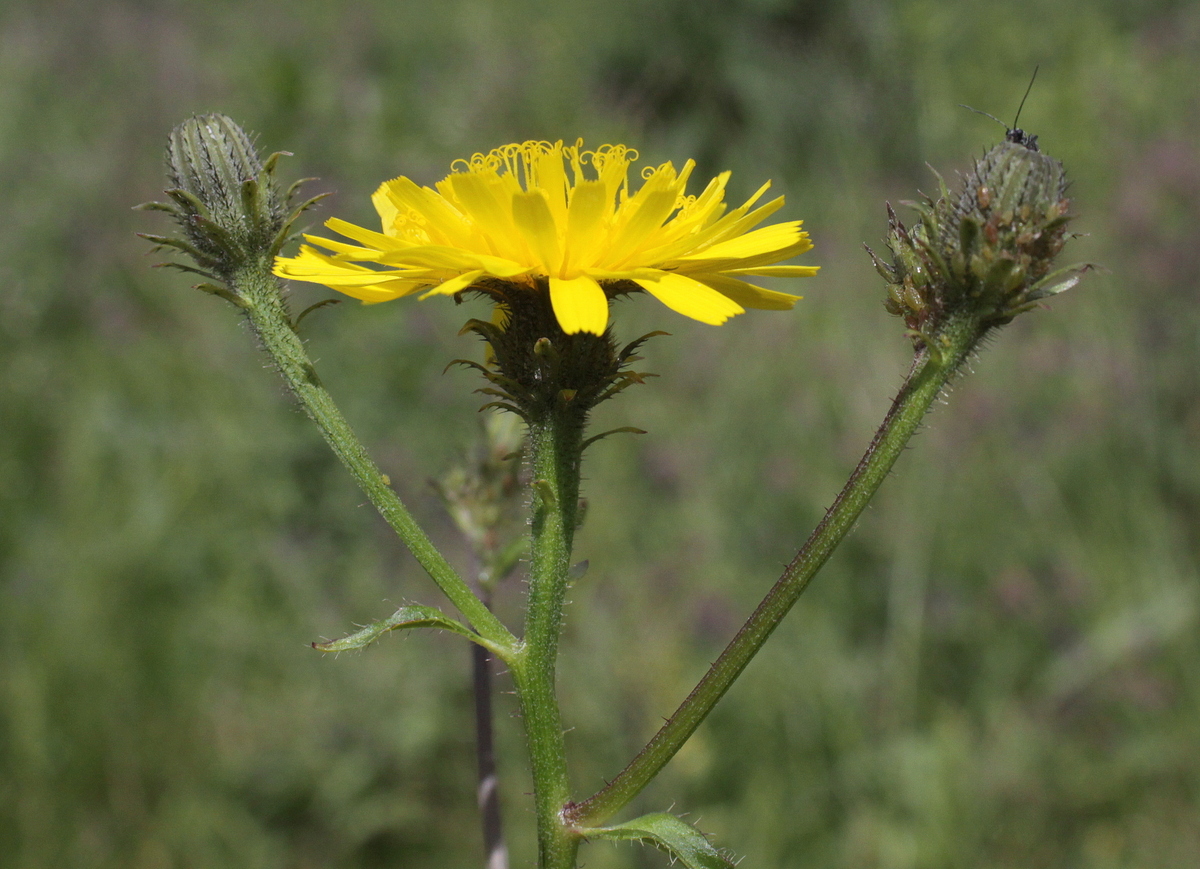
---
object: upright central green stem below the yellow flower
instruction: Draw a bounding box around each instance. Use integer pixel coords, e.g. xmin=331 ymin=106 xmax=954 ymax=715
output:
xmin=509 ymin=406 xmax=583 ymax=869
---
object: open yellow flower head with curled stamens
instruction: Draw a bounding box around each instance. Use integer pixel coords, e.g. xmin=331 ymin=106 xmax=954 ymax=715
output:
xmin=275 ymin=140 xmax=817 ymax=335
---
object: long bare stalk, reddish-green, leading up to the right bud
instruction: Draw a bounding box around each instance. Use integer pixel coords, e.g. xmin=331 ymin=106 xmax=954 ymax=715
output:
xmin=564 ymin=317 xmax=982 ymax=833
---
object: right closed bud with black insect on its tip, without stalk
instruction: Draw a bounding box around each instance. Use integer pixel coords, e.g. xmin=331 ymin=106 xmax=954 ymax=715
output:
xmin=868 ymin=71 xmax=1087 ymax=348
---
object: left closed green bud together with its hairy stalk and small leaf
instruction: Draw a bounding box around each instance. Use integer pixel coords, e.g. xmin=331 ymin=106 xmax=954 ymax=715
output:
xmin=142 ymin=115 xmax=517 ymax=661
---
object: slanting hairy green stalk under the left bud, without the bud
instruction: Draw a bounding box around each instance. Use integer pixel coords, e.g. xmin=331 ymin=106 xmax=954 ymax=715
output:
xmin=232 ymin=258 xmax=517 ymax=659
